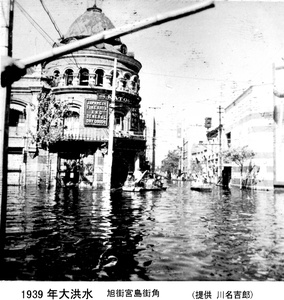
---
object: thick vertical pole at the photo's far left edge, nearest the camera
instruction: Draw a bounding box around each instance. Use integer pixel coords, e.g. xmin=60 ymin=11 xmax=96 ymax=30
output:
xmin=0 ymin=0 xmax=14 ymax=258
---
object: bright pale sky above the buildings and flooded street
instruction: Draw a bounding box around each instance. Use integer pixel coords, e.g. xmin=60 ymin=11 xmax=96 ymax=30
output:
xmin=10 ymin=0 xmax=284 ymax=163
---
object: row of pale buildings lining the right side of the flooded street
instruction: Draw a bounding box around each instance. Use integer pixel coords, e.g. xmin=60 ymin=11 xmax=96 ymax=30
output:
xmin=182 ymin=66 xmax=284 ymax=190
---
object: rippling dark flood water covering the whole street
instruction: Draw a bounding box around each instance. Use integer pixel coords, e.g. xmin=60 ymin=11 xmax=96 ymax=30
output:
xmin=0 ymin=182 xmax=284 ymax=281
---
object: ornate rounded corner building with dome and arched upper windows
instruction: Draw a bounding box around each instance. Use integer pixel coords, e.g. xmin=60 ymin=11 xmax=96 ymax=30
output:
xmin=8 ymin=5 xmax=146 ymax=188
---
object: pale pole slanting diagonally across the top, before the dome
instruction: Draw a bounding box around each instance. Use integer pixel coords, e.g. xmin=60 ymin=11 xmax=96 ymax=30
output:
xmin=20 ymin=1 xmax=214 ymax=67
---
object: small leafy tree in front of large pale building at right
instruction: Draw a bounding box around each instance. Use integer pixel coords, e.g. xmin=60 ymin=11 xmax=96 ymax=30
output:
xmin=222 ymin=146 xmax=255 ymax=189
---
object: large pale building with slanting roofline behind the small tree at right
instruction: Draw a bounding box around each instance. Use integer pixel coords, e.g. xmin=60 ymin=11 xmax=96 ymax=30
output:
xmin=224 ymin=84 xmax=276 ymax=189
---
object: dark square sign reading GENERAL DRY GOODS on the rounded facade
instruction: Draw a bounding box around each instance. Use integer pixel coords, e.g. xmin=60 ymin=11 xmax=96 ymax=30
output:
xmin=85 ymin=99 xmax=109 ymax=127
